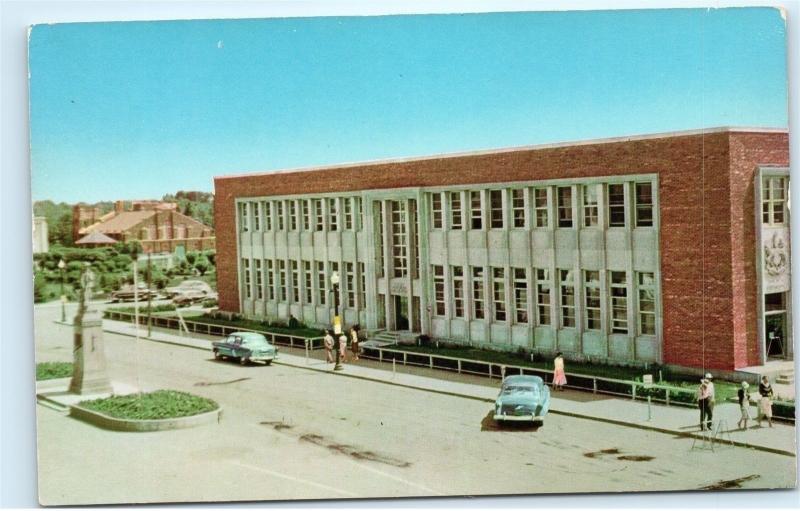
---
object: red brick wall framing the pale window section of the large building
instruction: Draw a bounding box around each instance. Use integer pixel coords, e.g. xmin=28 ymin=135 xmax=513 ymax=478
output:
xmin=214 ymin=132 xmax=788 ymax=369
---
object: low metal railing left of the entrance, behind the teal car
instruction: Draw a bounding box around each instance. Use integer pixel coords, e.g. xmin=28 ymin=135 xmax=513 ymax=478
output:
xmin=103 ymin=309 xmax=324 ymax=350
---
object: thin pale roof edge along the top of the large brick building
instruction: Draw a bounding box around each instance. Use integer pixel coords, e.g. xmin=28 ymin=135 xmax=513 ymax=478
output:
xmin=214 ymin=126 xmax=789 ymax=180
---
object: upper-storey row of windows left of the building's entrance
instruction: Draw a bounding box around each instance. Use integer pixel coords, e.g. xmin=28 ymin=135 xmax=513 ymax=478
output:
xmin=238 ymin=197 xmax=366 ymax=232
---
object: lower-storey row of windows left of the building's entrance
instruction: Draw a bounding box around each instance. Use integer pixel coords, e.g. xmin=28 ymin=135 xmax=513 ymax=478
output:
xmin=242 ymin=258 xmax=367 ymax=308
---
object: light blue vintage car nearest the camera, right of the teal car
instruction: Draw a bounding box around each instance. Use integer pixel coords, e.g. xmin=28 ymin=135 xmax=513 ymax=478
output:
xmin=494 ymin=375 xmax=550 ymax=422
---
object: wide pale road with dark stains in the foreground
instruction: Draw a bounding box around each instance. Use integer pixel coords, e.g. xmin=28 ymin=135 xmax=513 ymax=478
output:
xmin=35 ymin=305 xmax=796 ymax=504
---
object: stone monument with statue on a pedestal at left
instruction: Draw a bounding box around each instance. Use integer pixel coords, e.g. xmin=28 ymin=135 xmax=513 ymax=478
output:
xmin=69 ymin=263 xmax=113 ymax=395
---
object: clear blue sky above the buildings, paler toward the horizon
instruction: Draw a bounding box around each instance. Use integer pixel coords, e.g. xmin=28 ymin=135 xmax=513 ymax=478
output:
xmin=29 ymin=8 xmax=788 ymax=202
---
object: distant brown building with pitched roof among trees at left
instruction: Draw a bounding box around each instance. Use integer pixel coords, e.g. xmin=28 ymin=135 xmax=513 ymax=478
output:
xmin=73 ymin=201 xmax=215 ymax=253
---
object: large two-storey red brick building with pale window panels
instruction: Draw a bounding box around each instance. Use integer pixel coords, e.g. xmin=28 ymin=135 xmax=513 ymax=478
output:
xmin=215 ymin=128 xmax=793 ymax=370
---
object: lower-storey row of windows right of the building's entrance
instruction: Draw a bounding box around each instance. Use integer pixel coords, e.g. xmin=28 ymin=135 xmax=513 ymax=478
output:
xmin=431 ymin=265 xmax=656 ymax=335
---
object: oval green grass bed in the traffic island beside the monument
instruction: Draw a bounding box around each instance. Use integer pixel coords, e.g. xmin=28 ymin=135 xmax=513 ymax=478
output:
xmin=80 ymin=390 xmax=219 ymax=420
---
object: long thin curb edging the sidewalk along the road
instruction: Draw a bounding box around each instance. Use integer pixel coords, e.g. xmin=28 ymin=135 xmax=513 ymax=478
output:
xmin=107 ymin=330 xmax=796 ymax=457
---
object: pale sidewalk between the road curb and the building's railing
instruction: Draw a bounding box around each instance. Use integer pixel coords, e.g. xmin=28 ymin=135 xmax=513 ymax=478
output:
xmin=103 ymin=320 xmax=796 ymax=456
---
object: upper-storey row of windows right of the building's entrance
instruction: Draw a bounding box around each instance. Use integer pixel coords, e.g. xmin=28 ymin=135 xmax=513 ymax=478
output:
xmin=430 ymin=182 xmax=653 ymax=230
